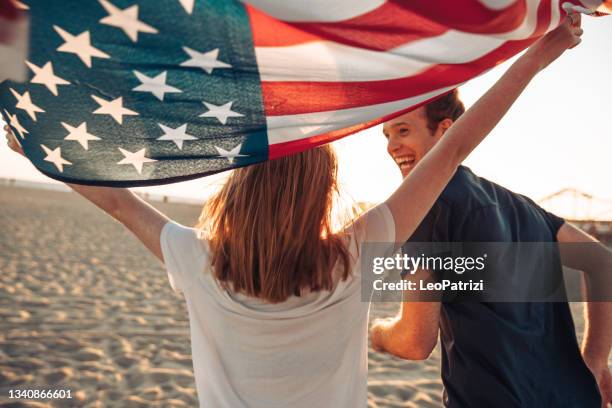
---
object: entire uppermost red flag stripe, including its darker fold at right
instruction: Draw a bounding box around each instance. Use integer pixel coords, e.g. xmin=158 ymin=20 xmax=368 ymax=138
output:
xmin=248 ymin=0 xmax=537 ymax=50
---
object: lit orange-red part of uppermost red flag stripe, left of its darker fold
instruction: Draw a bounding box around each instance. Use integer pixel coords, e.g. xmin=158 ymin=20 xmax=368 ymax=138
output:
xmin=247 ymin=2 xmax=448 ymax=51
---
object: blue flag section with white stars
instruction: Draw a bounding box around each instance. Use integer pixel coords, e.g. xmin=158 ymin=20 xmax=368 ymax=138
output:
xmin=0 ymin=0 xmax=268 ymax=186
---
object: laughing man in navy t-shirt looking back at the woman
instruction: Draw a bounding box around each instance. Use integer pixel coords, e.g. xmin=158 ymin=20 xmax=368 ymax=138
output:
xmin=371 ymin=91 xmax=612 ymax=408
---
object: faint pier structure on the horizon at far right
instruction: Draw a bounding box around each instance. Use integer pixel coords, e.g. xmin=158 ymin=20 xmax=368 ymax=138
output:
xmin=538 ymin=188 xmax=612 ymax=245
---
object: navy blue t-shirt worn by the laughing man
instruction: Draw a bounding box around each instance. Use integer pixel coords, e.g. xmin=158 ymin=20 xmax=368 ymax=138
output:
xmin=410 ymin=166 xmax=601 ymax=408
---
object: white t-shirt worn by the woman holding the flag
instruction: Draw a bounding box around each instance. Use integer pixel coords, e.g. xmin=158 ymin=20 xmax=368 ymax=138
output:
xmin=161 ymin=204 xmax=395 ymax=408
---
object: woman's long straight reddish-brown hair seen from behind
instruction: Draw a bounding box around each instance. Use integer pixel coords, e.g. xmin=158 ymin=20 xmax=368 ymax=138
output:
xmin=197 ymin=145 xmax=350 ymax=303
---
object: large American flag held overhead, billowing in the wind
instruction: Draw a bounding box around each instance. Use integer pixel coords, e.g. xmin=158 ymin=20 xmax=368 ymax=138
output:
xmin=0 ymin=0 xmax=602 ymax=187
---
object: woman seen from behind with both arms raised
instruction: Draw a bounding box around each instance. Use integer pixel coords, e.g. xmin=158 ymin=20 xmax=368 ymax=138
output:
xmin=7 ymin=18 xmax=582 ymax=408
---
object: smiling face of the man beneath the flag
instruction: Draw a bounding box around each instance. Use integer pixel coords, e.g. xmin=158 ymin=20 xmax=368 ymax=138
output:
xmin=383 ymin=107 xmax=444 ymax=177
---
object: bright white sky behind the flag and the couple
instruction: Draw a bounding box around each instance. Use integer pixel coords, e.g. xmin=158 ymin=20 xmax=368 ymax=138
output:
xmin=0 ymin=16 xmax=612 ymax=219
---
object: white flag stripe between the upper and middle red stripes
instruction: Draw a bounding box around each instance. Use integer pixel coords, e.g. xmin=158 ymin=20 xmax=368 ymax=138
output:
xmin=255 ymin=30 xmax=504 ymax=82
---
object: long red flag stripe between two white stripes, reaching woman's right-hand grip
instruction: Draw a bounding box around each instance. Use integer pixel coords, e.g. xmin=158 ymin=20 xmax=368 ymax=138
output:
xmin=261 ymin=2 xmax=551 ymax=116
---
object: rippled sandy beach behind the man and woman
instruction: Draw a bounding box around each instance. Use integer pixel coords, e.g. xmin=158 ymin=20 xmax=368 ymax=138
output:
xmin=0 ymin=187 xmax=604 ymax=407
